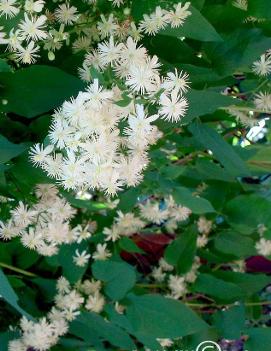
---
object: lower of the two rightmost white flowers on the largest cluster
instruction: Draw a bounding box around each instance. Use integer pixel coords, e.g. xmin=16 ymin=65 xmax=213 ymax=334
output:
xmin=158 ymin=90 xmax=188 ymax=122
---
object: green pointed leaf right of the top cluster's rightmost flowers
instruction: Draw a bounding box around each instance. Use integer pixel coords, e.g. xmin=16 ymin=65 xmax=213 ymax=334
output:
xmin=159 ymin=6 xmax=223 ymax=41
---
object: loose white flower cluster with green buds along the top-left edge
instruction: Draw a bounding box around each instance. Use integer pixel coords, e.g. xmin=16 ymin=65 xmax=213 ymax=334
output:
xmin=0 ymin=0 xmax=191 ymax=64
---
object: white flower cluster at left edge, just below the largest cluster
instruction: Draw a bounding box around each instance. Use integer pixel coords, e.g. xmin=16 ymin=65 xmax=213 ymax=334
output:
xmin=0 ymin=184 xmax=94 ymax=256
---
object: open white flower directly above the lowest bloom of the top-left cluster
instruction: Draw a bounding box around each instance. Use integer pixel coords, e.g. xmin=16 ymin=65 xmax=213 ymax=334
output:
xmin=19 ymin=12 xmax=47 ymax=41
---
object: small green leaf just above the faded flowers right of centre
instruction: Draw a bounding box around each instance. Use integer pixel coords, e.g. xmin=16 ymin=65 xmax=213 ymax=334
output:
xmin=172 ymin=186 xmax=214 ymax=214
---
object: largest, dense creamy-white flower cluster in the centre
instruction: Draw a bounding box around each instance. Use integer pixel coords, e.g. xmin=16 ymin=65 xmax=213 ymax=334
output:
xmin=30 ymin=37 xmax=188 ymax=195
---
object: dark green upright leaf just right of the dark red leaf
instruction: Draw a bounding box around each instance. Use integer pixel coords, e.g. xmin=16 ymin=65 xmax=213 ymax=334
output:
xmin=165 ymin=228 xmax=197 ymax=274
